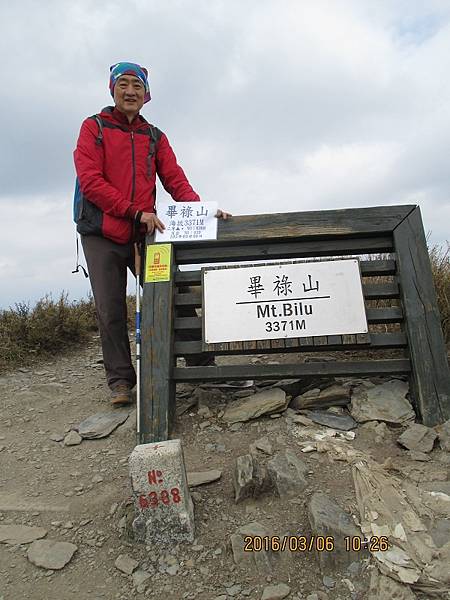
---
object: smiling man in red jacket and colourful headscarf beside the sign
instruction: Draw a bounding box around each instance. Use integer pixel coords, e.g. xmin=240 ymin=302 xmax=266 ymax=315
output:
xmin=74 ymin=62 xmax=230 ymax=405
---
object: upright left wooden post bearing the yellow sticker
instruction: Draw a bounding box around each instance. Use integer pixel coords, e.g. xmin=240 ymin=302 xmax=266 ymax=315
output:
xmin=140 ymin=241 xmax=175 ymax=444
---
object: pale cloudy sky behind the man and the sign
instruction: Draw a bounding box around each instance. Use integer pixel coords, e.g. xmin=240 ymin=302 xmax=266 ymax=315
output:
xmin=0 ymin=0 xmax=450 ymax=308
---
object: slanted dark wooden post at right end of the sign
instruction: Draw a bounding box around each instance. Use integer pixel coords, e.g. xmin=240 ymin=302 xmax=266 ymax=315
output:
xmin=394 ymin=207 xmax=450 ymax=427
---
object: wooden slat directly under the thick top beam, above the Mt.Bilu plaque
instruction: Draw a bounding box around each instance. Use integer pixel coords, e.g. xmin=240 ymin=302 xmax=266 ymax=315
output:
xmin=174 ymin=235 xmax=394 ymax=265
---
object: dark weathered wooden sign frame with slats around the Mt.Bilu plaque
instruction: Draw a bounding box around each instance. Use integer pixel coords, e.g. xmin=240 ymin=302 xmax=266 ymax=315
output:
xmin=140 ymin=205 xmax=450 ymax=443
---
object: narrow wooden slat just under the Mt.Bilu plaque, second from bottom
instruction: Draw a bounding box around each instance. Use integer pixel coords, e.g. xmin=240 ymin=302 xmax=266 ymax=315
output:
xmin=175 ymin=332 xmax=407 ymax=356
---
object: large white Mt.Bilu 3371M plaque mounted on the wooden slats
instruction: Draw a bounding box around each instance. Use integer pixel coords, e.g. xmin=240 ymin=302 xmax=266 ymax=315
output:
xmin=203 ymin=259 xmax=368 ymax=344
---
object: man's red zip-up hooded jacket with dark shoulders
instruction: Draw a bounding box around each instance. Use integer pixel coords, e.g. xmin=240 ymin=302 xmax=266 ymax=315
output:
xmin=74 ymin=107 xmax=200 ymax=244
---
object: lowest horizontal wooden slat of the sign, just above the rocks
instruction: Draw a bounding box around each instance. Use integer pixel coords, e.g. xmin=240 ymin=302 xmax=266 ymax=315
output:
xmin=173 ymin=358 xmax=411 ymax=382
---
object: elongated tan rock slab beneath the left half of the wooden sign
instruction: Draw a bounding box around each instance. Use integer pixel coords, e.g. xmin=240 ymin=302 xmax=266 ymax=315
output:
xmin=223 ymin=388 xmax=286 ymax=423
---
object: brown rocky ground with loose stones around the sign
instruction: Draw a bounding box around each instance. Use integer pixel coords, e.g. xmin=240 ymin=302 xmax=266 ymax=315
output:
xmin=0 ymin=339 xmax=450 ymax=600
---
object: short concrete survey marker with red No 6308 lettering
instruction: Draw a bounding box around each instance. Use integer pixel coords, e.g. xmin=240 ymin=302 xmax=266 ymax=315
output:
xmin=129 ymin=440 xmax=195 ymax=545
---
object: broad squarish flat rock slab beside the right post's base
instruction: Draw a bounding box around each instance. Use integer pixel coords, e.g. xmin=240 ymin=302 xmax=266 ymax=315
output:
xmin=350 ymin=379 xmax=416 ymax=424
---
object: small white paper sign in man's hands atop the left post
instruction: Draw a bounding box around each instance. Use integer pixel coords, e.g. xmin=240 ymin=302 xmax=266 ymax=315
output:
xmin=155 ymin=201 xmax=217 ymax=243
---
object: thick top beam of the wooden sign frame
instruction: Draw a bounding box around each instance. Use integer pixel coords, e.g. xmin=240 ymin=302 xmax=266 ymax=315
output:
xmin=157 ymin=205 xmax=415 ymax=247
